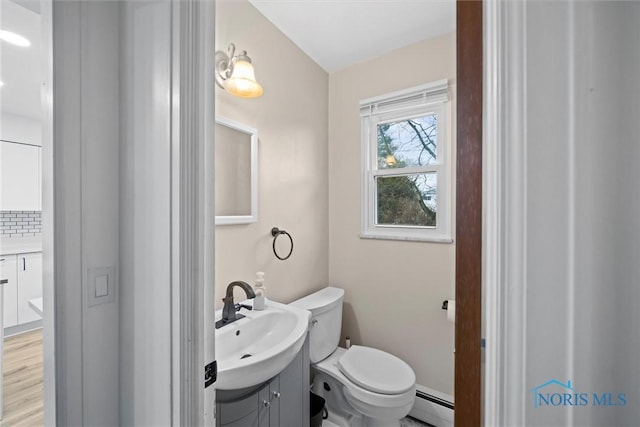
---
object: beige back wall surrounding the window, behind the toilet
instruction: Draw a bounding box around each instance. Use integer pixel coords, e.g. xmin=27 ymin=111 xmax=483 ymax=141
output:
xmin=329 ymin=33 xmax=455 ymax=395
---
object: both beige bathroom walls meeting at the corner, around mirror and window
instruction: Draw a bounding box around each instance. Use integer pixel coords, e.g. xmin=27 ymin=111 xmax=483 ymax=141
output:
xmin=215 ymin=1 xmax=455 ymax=394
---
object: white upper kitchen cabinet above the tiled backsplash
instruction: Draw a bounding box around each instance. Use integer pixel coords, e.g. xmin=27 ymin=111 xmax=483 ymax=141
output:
xmin=0 ymin=141 xmax=42 ymax=211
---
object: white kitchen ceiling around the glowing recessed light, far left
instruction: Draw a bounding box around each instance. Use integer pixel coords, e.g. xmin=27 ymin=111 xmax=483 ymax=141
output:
xmin=0 ymin=0 xmax=42 ymax=119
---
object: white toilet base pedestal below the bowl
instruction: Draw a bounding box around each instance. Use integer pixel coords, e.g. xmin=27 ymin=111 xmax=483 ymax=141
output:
xmin=313 ymin=369 xmax=400 ymax=427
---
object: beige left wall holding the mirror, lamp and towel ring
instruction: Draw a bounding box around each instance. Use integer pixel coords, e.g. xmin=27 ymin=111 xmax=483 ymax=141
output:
xmin=215 ymin=1 xmax=329 ymax=308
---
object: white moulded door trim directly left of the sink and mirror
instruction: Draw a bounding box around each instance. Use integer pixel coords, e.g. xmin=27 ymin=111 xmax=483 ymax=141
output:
xmin=171 ymin=0 xmax=215 ymax=426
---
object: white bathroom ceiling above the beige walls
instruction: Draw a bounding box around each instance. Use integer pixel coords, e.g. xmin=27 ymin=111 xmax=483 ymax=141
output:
xmin=249 ymin=0 xmax=455 ymax=73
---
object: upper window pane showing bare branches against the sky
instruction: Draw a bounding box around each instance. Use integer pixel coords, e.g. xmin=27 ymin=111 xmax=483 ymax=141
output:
xmin=378 ymin=114 xmax=438 ymax=169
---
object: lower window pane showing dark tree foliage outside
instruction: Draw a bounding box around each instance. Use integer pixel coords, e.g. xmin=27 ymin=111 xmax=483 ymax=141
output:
xmin=376 ymin=172 xmax=437 ymax=227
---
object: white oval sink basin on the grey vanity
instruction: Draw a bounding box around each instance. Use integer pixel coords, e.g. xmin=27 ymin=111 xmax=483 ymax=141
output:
xmin=216 ymin=300 xmax=311 ymax=390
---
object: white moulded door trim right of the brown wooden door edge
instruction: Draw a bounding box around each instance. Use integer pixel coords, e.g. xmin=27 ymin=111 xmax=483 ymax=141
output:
xmin=482 ymin=0 xmax=527 ymax=426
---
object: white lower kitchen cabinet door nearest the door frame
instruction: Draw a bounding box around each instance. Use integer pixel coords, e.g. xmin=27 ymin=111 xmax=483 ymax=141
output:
xmin=17 ymin=252 xmax=42 ymax=325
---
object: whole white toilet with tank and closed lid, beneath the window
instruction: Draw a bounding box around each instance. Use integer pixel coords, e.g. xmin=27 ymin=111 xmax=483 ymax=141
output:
xmin=291 ymin=287 xmax=416 ymax=427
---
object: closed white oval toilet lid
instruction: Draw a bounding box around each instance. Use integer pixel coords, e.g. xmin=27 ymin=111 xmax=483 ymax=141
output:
xmin=337 ymin=345 xmax=416 ymax=394
